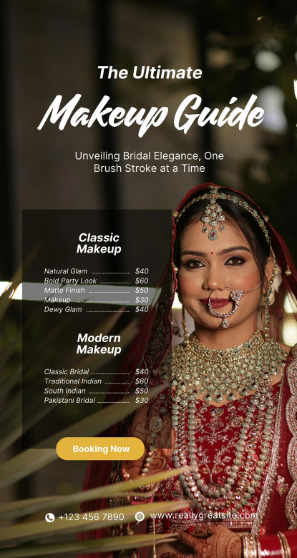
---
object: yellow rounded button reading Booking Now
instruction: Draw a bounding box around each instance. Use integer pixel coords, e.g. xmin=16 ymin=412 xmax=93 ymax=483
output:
xmin=56 ymin=437 xmax=145 ymax=461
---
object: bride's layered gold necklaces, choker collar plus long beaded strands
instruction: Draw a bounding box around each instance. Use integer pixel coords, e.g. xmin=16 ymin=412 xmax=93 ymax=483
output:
xmin=161 ymin=330 xmax=287 ymax=513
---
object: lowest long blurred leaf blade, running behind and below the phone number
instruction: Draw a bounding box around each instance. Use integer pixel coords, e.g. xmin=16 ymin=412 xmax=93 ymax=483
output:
xmin=0 ymin=500 xmax=185 ymax=546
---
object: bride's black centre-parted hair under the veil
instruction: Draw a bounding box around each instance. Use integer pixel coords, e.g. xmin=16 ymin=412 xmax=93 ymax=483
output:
xmin=174 ymin=188 xmax=270 ymax=279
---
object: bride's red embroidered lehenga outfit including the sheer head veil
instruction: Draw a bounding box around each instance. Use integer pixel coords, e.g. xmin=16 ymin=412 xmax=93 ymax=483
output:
xmin=79 ymin=184 xmax=297 ymax=558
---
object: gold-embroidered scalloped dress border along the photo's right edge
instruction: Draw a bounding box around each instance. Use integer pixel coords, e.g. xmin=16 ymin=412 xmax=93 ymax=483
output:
xmin=285 ymin=345 xmax=297 ymax=528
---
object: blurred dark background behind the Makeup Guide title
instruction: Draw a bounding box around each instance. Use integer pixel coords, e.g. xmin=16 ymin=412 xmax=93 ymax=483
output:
xmin=0 ymin=0 xmax=297 ymax=556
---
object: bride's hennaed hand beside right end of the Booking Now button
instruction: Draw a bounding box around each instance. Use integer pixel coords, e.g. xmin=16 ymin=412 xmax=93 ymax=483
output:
xmin=124 ymin=398 xmax=175 ymax=479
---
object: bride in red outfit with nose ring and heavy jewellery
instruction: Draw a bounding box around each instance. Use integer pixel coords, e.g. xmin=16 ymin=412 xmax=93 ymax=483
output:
xmin=80 ymin=184 xmax=297 ymax=558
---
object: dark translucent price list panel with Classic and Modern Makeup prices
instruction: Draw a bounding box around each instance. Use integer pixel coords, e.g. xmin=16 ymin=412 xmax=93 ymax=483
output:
xmin=22 ymin=210 xmax=171 ymax=446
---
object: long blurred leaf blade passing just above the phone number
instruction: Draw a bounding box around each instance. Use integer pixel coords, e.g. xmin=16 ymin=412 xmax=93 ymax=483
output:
xmin=0 ymin=467 xmax=190 ymax=520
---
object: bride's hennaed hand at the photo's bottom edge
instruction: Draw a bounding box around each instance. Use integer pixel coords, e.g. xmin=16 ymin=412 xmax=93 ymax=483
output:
xmin=161 ymin=525 xmax=242 ymax=558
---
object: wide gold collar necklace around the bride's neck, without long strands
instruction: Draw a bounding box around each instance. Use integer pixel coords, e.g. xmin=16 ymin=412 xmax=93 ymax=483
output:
xmin=161 ymin=330 xmax=287 ymax=406
